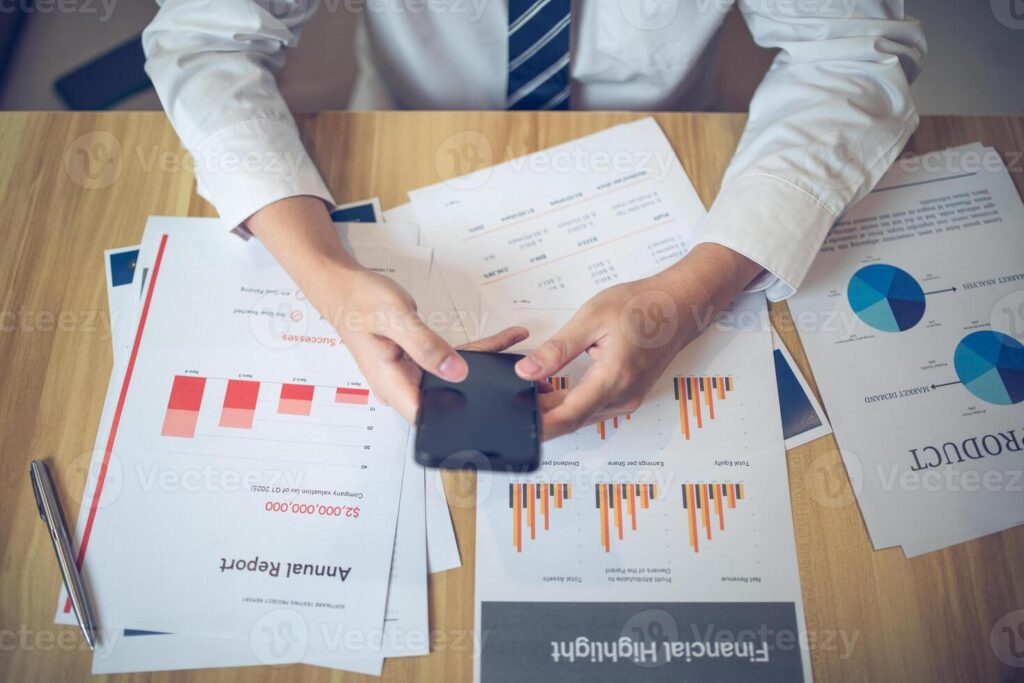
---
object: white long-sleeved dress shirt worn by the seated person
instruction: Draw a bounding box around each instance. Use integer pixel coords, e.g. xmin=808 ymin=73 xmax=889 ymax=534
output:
xmin=142 ymin=0 xmax=926 ymax=300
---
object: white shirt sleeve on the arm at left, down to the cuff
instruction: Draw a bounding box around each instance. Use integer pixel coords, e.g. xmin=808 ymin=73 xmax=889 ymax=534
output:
xmin=142 ymin=0 xmax=334 ymax=234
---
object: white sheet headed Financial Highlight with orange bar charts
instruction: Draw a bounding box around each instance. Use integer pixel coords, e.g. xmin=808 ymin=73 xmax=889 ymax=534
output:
xmin=475 ymin=295 xmax=811 ymax=682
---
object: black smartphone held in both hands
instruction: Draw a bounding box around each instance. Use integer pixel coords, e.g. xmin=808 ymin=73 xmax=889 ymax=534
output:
xmin=416 ymin=351 xmax=541 ymax=472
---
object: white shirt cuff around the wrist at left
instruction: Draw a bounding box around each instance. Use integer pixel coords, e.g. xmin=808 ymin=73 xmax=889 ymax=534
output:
xmin=193 ymin=119 xmax=335 ymax=237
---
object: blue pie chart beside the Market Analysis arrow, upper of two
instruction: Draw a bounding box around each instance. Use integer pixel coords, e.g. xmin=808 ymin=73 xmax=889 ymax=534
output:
xmin=846 ymin=263 xmax=925 ymax=332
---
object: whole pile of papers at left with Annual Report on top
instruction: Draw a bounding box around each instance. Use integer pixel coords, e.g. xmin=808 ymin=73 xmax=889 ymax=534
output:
xmin=57 ymin=202 xmax=460 ymax=674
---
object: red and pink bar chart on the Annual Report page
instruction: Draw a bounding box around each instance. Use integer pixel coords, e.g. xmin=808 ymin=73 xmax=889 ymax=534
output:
xmin=160 ymin=374 xmax=370 ymax=438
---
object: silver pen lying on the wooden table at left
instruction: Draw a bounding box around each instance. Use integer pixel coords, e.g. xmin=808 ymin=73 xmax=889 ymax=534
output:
xmin=29 ymin=460 xmax=97 ymax=649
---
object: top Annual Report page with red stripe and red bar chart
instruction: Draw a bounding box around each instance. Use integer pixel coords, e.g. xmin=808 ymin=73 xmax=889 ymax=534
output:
xmin=59 ymin=218 xmax=429 ymax=659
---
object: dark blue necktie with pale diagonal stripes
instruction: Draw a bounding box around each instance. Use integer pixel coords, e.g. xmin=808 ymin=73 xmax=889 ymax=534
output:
xmin=506 ymin=0 xmax=572 ymax=110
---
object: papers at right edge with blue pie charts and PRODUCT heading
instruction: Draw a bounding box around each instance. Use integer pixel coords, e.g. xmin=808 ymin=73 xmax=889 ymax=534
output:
xmin=790 ymin=144 xmax=1024 ymax=556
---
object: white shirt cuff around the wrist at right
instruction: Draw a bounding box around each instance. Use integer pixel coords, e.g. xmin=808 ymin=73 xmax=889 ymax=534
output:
xmin=696 ymin=174 xmax=837 ymax=301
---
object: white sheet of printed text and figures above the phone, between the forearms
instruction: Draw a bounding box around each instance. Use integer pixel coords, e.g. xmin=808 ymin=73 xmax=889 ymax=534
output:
xmin=410 ymin=119 xmax=706 ymax=339
